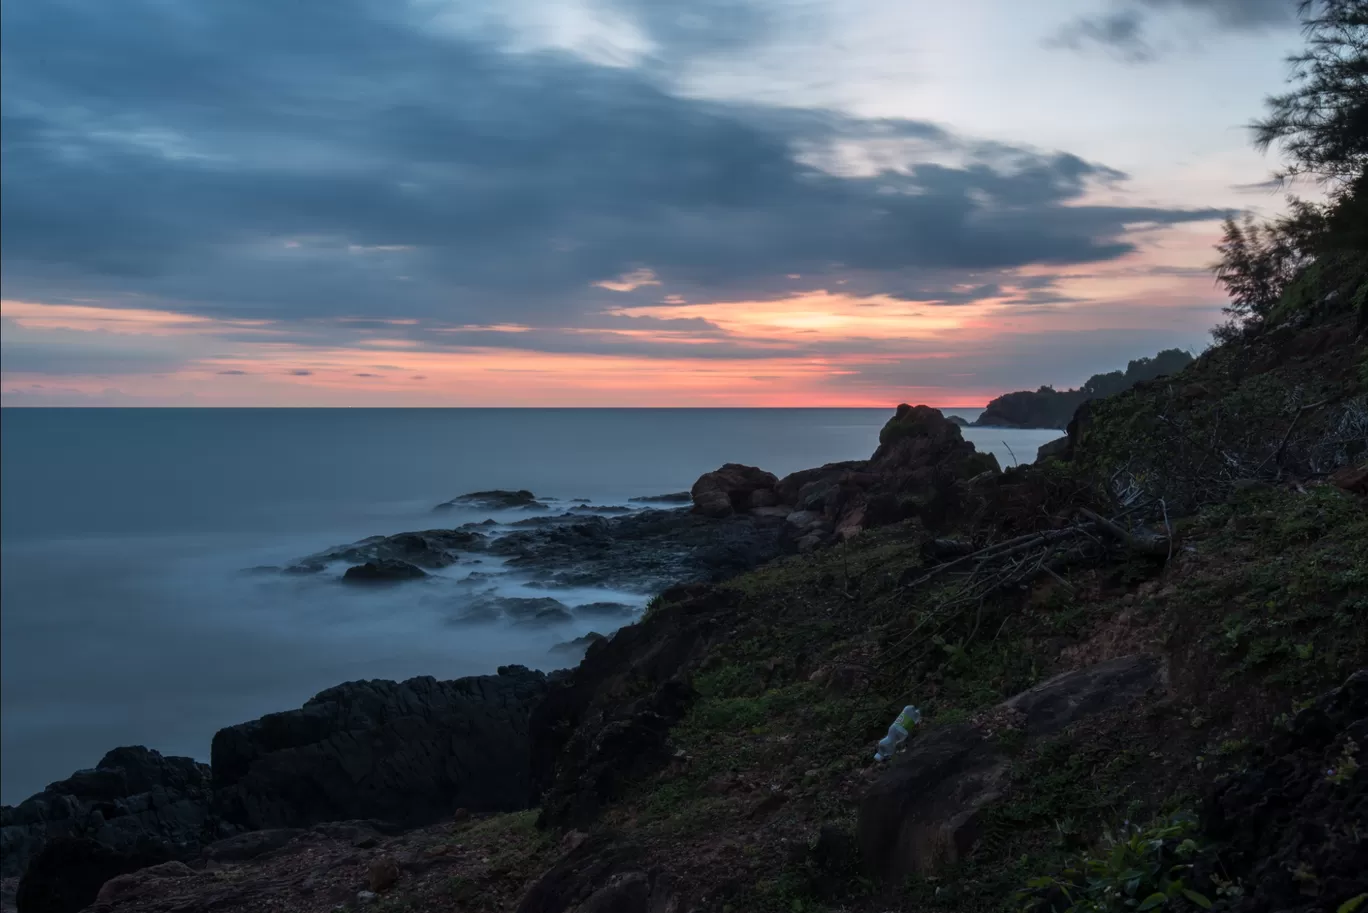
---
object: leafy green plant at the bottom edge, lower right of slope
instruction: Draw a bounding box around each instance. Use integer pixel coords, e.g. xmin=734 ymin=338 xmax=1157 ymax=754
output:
xmin=1016 ymin=814 xmax=1212 ymax=913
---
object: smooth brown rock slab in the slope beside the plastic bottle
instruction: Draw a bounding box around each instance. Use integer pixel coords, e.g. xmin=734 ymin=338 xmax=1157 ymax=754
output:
xmin=859 ymin=656 xmax=1164 ymax=882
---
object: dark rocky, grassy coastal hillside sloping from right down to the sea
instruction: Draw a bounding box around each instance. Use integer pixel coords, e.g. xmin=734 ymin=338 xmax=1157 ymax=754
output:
xmin=5 ymin=310 xmax=1368 ymax=913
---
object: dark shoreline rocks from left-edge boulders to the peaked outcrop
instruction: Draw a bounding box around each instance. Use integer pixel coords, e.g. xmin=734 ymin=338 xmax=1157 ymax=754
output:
xmin=0 ymin=405 xmax=999 ymax=910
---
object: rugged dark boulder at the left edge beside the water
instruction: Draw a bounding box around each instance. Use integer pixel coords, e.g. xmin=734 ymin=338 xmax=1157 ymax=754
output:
xmin=0 ymin=746 xmax=234 ymax=888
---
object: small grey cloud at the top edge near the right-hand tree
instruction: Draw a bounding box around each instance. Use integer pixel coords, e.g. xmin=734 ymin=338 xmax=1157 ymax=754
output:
xmin=1045 ymin=0 xmax=1297 ymax=63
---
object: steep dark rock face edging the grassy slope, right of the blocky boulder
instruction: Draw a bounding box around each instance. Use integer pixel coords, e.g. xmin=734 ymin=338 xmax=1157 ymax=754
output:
xmin=531 ymin=587 xmax=737 ymax=827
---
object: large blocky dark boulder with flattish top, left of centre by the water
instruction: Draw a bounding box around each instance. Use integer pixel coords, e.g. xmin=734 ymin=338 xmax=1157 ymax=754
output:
xmin=211 ymin=665 xmax=546 ymax=830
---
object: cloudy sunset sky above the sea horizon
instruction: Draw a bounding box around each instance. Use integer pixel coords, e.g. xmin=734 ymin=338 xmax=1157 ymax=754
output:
xmin=0 ymin=0 xmax=1300 ymax=407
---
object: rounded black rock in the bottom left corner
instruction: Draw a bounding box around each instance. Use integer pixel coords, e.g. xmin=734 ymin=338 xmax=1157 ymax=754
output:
xmin=15 ymin=836 xmax=170 ymax=913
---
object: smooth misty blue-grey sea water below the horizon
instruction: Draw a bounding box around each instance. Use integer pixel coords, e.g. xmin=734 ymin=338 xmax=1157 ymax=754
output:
xmin=0 ymin=409 xmax=1057 ymax=803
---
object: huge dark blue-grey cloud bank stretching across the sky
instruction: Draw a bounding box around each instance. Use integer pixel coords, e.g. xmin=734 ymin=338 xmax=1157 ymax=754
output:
xmin=0 ymin=0 xmax=1215 ymax=333
